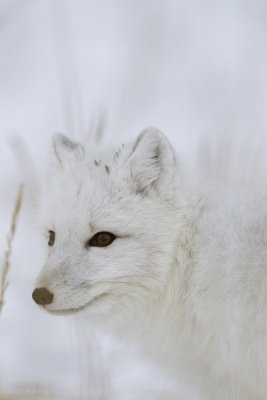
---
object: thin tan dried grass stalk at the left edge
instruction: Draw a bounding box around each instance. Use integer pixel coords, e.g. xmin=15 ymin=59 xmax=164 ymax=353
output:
xmin=0 ymin=184 xmax=23 ymax=312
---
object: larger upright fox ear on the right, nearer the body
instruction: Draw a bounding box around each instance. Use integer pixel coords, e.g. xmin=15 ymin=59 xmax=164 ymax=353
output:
xmin=128 ymin=127 xmax=176 ymax=193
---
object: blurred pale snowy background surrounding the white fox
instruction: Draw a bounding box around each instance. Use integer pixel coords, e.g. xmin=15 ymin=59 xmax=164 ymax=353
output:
xmin=0 ymin=0 xmax=267 ymax=400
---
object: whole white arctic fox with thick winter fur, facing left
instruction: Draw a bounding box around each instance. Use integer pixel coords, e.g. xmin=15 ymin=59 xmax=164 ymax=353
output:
xmin=33 ymin=128 xmax=267 ymax=400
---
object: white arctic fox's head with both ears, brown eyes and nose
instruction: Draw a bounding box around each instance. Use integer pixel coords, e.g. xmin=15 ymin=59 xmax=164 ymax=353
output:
xmin=33 ymin=128 xmax=179 ymax=314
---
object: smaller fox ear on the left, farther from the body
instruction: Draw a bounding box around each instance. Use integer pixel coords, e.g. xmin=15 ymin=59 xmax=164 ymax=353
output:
xmin=51 ymin=133 xmax=85 ymax=169
